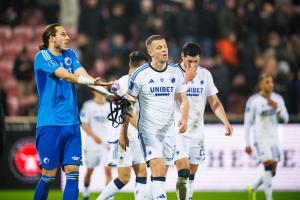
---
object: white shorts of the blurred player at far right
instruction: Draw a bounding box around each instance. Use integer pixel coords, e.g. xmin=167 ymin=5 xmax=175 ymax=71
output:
xmin=254 ymin=141 xmax=280 ymax=162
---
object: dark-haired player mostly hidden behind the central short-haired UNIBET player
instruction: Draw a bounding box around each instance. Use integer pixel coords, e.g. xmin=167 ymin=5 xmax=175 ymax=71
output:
xmin=97 ymin=51 xmax=148 ymax=200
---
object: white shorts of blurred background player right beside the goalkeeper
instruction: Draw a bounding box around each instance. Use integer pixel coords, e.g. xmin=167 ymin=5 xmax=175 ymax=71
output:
xmin=84 ymin=143 xmax=117 ymax=168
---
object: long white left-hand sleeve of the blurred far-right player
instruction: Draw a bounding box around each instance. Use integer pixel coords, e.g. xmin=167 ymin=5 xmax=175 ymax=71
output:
xmin=244 ymin=97 xmax=255 ymax=146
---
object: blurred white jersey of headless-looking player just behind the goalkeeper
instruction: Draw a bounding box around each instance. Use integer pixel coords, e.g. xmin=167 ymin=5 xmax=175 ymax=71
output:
xmin=80 ymin=100 xmax=120 ymax=150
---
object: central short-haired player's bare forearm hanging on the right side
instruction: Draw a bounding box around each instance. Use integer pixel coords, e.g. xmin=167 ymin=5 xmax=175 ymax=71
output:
xmin=176 ymin=92 xmax=190 ymax=133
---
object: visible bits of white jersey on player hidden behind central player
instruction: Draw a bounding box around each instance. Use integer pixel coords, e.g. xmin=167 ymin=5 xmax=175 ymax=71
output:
xmin=118 ymin=75 xmax=138 ymax=141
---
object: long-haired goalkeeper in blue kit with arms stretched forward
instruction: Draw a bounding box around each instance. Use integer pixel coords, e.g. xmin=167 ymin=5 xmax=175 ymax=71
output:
xmin=34 ymin=24 xmax=111 ymax=200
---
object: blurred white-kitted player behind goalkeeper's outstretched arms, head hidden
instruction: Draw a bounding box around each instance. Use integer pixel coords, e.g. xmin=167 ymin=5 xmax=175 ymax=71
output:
xmin=80 ymin=92 xmax=119 ymax=200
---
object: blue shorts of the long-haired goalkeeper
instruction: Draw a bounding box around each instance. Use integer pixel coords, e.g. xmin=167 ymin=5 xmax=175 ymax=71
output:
xmin=36 ymin=125 xmax=82 ymax=170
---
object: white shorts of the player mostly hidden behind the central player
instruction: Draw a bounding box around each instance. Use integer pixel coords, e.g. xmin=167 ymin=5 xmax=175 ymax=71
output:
xmin=117 ymin=139 xmax=145 ymax=167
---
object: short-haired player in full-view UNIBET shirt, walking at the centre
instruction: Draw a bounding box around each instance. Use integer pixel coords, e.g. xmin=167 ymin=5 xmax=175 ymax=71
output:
xmin=120 ymin=35 xmax=189 ymax=199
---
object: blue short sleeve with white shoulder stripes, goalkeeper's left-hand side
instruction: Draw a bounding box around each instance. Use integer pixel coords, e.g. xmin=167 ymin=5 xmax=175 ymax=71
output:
xmin=34 ymin=50 xmax=60 ymax=75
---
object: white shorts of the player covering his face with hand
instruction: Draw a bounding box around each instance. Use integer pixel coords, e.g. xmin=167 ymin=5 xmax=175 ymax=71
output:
xmin=174 ymin=134 xmax=205 ymax=165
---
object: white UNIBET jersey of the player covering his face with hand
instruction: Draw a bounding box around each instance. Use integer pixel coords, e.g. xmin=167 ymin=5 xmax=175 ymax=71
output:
xmin=176 ymin=64 xmax=218 ymax=138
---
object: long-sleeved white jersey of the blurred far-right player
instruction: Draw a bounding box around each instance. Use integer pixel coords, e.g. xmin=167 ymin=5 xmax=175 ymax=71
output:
xmin=244 ymin=93 xmax=289 ymax=146
